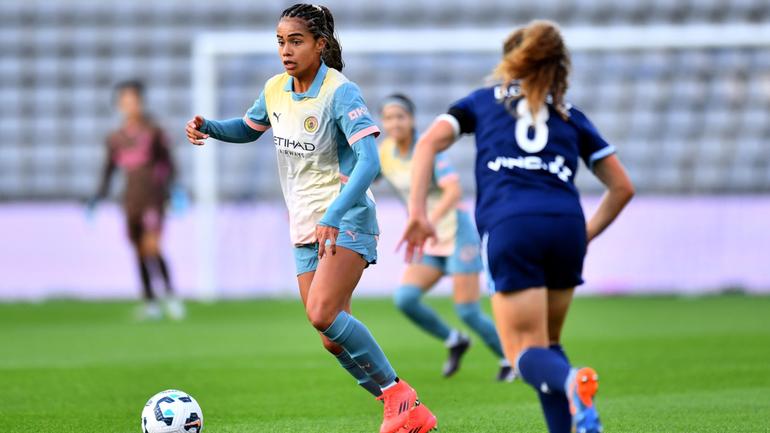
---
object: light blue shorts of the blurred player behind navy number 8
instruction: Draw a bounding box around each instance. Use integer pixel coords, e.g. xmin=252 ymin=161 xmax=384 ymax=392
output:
xmin=421 ymin=210 xmax=484 ymax=275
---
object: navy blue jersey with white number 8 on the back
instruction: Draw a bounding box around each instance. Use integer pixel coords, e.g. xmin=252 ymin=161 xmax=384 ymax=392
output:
xmin=449 ymin=84 xmax=615 ymax=233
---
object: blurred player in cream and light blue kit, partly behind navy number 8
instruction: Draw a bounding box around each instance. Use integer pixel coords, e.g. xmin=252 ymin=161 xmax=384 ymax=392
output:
xmin=380 ymin=94 xmax=514 ymax=381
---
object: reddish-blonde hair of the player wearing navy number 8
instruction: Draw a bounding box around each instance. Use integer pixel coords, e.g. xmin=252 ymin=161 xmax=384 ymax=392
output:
xmin=493 ymin=21 xmax=570 ymax=120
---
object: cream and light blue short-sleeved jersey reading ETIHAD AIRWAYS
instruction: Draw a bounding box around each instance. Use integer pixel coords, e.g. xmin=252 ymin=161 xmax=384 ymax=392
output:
xmin=243 ymin=64 xmax=380 ymax=245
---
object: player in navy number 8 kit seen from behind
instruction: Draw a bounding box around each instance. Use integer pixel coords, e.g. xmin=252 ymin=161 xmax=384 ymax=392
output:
xmin=403 ymin=21 xmax=634 ymax=433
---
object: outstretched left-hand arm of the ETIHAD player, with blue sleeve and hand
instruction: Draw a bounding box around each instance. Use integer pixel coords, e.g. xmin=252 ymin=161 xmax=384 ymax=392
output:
xmin=185 ymin=88 xmax=270 ymax=145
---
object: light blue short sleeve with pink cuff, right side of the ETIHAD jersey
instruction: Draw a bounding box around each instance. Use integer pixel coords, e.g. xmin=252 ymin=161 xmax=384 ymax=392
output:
xmin=332 ymin=82 xmax=380 ymax=146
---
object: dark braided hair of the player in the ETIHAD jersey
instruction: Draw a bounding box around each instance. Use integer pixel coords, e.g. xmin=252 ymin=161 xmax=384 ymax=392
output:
xmin=281 ymin=3 xmax=345 ymax=71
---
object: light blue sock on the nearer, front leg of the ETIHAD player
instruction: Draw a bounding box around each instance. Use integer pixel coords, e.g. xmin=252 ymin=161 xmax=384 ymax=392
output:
xmin=323 ymin=311 xmax=396 ymax=387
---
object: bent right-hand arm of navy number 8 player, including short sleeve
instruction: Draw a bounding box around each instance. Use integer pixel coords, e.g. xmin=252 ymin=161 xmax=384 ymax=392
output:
xmin=572 ymin=111 xmax=634 ymax=242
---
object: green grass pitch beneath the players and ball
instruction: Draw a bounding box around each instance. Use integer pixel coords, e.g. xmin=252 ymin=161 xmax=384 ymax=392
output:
xmin=0 ymin=295 xmax=770 ymax=433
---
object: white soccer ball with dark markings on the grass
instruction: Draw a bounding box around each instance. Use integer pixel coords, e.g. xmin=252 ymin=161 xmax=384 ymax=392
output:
xmin=142 ymin=389 xmax=203 ymax=433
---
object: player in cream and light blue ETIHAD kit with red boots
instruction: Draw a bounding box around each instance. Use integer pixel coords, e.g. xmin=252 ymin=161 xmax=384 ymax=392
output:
xmin=187 ymin=4 xmax=436 ymax=433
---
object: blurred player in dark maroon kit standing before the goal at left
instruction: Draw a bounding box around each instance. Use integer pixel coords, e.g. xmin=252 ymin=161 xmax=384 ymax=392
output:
xmin=89 ymin=80 xmax=184 ymax=319
